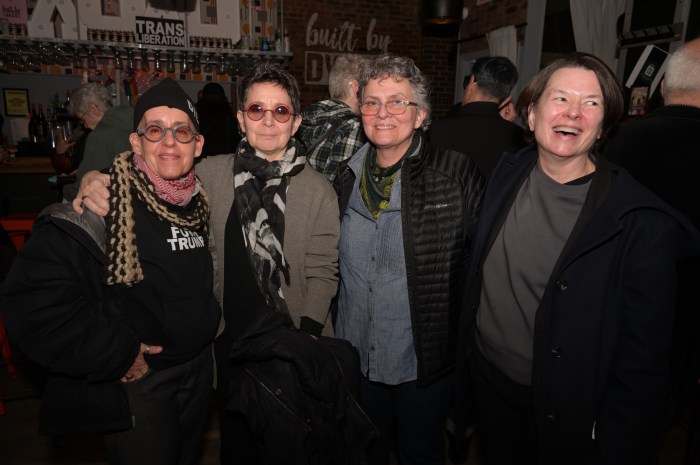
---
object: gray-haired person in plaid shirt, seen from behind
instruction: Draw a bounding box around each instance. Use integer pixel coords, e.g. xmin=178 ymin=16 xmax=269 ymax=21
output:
xmin=296 ymin=54 xmax=367 ymax=182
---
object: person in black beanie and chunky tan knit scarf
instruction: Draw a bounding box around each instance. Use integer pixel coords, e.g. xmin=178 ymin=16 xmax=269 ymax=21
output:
xmin=0 ymin=79 xmax=221 ymax=465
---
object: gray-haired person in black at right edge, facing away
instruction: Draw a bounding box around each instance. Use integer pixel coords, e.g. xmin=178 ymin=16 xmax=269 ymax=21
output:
xmin=605 ymin=39 xmax=700 ymax=428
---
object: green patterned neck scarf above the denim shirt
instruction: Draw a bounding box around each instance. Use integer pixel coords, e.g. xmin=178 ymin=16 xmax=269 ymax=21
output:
xmin=360 ymin=131 xmax=421 ymax=220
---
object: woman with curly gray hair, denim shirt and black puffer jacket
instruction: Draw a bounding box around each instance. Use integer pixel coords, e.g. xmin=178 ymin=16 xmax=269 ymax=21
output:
xmin=335 ymin=55 xmax=482 ymax=465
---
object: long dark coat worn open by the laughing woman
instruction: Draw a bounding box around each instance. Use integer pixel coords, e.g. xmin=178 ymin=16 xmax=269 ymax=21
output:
xmin=456 ymin=147 xmax=700 ymax=465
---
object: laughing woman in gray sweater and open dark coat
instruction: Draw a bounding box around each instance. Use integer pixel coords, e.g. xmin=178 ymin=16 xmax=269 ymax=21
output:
xmin=456 ymin=53 xmax=700 ymax=465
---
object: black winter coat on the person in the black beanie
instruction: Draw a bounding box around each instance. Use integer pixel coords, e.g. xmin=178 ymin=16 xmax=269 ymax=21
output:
xmin=0 ymin=204 xmax=139 ymax=435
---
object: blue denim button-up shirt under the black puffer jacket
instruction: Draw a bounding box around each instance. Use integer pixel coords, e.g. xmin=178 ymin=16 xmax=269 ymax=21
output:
xmin=335 ymin=145 xmax=417 ymax=385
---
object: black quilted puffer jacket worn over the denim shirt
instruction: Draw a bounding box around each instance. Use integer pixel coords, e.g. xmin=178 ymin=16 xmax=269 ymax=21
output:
xmin=334 ymin=133 xmax=484 ymax=386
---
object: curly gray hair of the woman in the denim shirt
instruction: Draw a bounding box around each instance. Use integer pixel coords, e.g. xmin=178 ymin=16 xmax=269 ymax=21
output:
xmin=357 ymin=53 xmax=430 ymax=130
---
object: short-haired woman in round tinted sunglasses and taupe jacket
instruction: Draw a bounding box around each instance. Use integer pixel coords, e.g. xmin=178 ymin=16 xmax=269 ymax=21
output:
xmin=197 ymin=62 xmax=350 ymax=464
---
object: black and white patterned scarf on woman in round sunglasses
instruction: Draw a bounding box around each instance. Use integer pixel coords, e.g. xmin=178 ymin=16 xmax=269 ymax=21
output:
xmin=233 ymin=138 xmax=306 ymax=313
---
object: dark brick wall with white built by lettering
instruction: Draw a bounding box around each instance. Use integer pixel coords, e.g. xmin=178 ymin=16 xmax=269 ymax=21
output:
xmin=284 ymin=0 xmax=527 ymax=116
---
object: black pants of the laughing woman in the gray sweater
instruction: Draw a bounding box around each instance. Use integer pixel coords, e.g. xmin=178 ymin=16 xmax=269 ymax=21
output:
xmin=469 ymin=349 xmax=537 ymax=465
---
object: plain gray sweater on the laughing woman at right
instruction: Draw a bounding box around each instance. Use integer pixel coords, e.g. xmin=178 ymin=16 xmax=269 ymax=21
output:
xmin=477 ymin=165 xmax=591 ymax=385
